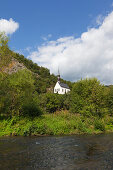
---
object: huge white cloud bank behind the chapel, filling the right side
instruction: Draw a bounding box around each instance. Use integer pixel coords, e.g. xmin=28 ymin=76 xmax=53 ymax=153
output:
xmin=28 ymin=12 xmax=113 ymax=84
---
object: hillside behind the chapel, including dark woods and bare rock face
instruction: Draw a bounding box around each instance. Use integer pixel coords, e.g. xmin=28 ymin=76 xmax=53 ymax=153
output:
xmin=0 ymin=49 xmax=72 ymax=93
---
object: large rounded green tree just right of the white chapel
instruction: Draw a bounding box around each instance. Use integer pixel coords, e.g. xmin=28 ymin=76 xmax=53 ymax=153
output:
xmin=71 ymin=78 xmax=108 ymax=117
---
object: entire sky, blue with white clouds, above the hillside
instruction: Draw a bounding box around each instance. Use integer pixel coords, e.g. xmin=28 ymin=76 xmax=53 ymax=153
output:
xmin=0 ymin=0 xmax=113 ymax=84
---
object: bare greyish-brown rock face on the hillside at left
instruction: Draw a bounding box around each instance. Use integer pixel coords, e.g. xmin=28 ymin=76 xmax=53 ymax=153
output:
xmin=2 ymin=58 xmax=26 ymax=74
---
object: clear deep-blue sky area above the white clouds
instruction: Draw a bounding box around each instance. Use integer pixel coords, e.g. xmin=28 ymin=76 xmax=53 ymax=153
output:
xmin=0 ymin=0 xmax=113 ymax=50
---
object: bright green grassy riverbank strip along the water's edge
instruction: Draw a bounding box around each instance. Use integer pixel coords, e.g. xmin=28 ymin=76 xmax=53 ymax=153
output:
xmin=0 ymin=111 xmax=113 ymax=136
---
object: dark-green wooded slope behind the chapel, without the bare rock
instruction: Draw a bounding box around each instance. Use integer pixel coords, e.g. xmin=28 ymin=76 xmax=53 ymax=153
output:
xmin=14 ymin=53 xmax=73 ymax=93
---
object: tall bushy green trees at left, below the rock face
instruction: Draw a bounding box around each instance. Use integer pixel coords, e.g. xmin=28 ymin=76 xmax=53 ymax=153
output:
xmin=0 ymin=69 xmax=41 ymax=116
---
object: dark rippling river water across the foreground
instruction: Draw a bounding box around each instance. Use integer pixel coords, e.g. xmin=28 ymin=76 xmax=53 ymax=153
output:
xmin=0 ymin=133 xmax=113 ymax=170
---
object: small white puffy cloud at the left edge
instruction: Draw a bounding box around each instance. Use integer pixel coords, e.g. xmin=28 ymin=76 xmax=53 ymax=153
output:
xmin=0 ymin=18 xmax=19 ymax=34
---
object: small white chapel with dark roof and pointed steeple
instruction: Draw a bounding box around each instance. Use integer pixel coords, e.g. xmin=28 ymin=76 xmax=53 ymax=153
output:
xmin=54 ymin=74 xmax=70 ymax=94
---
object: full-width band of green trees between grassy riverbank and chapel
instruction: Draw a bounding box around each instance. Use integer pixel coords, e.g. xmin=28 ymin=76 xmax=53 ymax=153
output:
xmin=0 ymin=69 xmax=113 ymax=117
